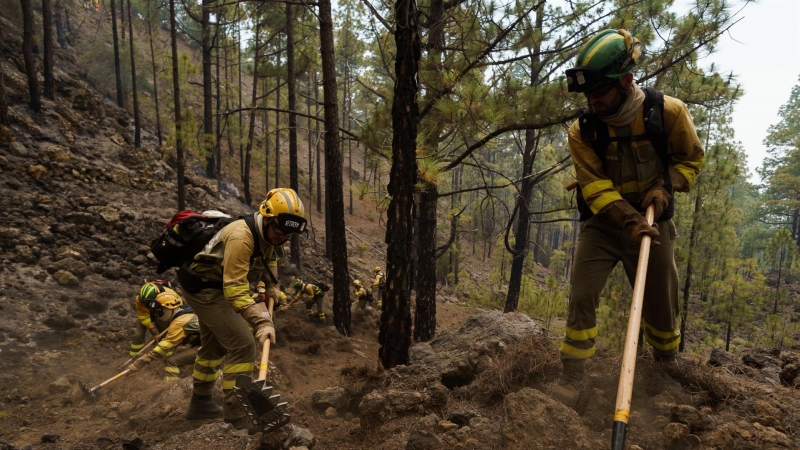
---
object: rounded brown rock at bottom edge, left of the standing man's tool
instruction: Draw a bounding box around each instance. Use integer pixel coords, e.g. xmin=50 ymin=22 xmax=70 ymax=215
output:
xmin=501 ymin=388 xmax=592 ymax=450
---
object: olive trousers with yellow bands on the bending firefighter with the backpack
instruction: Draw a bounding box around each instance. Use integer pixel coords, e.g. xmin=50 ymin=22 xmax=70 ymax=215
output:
xmin=184 ymin=289 xmax=256 ymax=420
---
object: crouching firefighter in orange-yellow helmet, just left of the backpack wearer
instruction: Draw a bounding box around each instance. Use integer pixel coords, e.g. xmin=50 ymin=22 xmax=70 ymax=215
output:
xmin=128 ymin=289 xmax=200 ymax=381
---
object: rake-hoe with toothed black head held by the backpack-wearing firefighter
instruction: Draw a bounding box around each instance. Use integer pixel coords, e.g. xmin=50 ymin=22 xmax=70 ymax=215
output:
xmin=233 ymin=298 xmax=292 ymax=434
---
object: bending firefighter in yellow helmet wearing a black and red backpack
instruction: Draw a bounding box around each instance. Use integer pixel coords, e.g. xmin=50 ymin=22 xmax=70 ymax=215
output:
xmin=178 ymin=188 xmax=306 ymax=429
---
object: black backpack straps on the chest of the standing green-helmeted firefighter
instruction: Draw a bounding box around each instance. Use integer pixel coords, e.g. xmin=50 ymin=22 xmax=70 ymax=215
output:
xmin=577 ymin=87 xmax=675 ymax=222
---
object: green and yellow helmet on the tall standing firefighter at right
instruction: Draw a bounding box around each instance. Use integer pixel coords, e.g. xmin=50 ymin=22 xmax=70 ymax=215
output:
xmin=566 ymin=29 xmax=641 ymax=92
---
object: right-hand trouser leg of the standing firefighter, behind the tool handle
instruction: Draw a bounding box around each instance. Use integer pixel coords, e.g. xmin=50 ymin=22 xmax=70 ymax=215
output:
xmin=623 ymin=220 xmax=681 ymax=355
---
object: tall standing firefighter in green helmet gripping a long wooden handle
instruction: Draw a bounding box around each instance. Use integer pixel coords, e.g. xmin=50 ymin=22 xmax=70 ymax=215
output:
xmin=552 ymin=30 xmax=704 ymax=406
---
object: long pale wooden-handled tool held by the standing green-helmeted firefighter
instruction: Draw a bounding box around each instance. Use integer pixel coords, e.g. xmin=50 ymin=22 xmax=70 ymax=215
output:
xmin=611 ymin=205 xmax=655 ymax=450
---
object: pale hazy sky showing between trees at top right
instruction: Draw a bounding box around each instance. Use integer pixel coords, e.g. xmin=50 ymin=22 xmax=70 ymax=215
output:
xmin=674 ymin=0 xmax=800 ymax=182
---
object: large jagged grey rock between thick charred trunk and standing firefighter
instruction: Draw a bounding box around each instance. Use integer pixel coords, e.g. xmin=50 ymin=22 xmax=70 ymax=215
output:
xmin=409 ymin=311 xmax=543 ymax=389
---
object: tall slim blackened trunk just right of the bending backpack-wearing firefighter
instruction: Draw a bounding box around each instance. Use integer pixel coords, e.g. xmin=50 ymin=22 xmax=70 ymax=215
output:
xmin=318 ymin=0 xmax=350 ymax=336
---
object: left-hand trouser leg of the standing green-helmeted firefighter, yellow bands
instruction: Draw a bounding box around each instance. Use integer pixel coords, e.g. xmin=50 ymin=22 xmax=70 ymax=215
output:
xmin=560 ymin=216 xmax=628 ymax=367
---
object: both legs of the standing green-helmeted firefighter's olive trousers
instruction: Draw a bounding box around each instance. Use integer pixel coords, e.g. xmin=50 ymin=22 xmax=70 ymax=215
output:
xmin=560 ymin=215 xmax=680 ymax=370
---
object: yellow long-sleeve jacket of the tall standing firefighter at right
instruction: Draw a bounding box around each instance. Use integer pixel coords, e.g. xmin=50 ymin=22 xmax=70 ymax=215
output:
xmin=568 ymin=95 xmax=704 ymax=214
